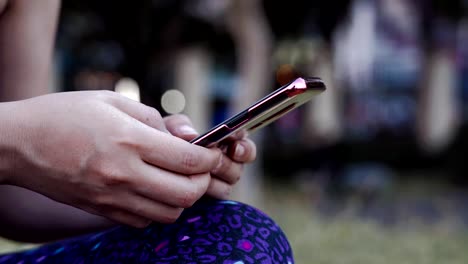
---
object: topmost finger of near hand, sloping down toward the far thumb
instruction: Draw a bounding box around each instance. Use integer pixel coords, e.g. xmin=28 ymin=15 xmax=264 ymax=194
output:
xmin=105 ymin=92 xmax=167 ymax=132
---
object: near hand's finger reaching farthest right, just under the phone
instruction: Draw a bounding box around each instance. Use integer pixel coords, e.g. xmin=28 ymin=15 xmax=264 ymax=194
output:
xmin=134 ymin=129 xmax=221 ymax=175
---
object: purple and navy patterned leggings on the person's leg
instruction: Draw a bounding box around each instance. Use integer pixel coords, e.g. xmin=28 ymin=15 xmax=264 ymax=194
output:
xmin=0 ymin=199 xmax=294 ymax=264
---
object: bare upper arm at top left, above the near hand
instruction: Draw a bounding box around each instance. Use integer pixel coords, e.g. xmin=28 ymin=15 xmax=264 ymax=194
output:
xmin=0 ymin=0 xmax=60 ymax=100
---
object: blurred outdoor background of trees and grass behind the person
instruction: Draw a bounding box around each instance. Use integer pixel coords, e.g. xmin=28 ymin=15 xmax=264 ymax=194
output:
xmin=0 ymin=0 xmax=468 ymax=263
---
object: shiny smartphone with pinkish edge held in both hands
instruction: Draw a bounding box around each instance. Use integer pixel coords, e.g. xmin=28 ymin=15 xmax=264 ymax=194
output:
xmin=191 ymin=78 xmax=326 ymax=147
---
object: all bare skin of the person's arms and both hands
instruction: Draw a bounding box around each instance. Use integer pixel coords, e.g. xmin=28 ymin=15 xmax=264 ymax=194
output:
xmin=0 ymin=0 xmax=256 ymax=242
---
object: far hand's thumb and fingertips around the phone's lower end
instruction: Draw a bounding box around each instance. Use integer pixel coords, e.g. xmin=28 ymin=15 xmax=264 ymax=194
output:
xmin=164 ymin=115 xmax=256 ymax=199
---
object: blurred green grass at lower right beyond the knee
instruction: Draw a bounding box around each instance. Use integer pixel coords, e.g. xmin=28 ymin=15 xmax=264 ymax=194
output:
xmin=265 ymin=184 xmax=468 ymax=264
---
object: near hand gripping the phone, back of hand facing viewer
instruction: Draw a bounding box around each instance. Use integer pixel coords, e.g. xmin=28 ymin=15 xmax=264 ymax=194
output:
xmin=0 ymin=91 xmax=222 ymax=227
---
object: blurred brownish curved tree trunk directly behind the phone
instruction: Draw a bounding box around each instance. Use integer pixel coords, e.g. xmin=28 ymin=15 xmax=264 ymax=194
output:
xmin=227 ymin=0 xmax=272 ymax=206
